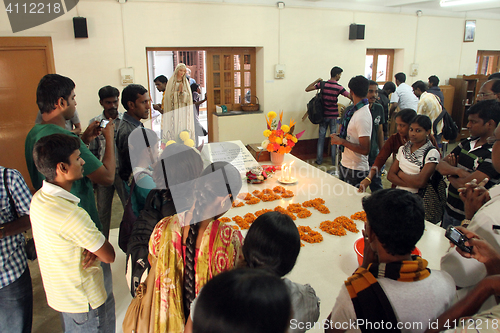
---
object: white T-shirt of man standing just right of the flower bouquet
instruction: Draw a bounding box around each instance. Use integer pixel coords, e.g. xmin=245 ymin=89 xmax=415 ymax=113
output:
xmin=341 ymin=105 xmax=373 ymax=171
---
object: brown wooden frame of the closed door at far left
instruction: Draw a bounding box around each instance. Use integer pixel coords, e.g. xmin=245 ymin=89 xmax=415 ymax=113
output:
xmin=0 ymin=37 xmax=56 ymax=74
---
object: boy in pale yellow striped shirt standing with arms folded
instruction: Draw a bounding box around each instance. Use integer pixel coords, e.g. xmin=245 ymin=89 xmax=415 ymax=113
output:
xmin=30 ymin=134 xmax=115 ymax=332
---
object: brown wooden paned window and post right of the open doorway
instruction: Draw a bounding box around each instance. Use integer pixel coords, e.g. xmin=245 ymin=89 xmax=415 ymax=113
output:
xmin=207 ymin=47 xmax=256 ymax=142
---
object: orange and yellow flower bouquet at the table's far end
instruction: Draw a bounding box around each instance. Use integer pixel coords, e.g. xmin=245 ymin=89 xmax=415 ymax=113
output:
xmin=262 ymin=111 xmax=305 ymax=154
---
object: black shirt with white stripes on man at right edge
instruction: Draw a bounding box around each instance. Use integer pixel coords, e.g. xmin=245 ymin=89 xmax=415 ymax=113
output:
xmin=446 ymin=138 xmax=500 ymax=220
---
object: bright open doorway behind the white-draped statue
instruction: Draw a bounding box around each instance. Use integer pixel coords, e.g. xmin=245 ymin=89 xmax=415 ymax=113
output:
xmin=146 ymin=48 xmax=208 ymax=143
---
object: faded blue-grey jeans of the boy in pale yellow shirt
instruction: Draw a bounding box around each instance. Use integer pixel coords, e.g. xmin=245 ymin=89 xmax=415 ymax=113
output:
xmin=61 ymin=304 xmax=106 ymax=333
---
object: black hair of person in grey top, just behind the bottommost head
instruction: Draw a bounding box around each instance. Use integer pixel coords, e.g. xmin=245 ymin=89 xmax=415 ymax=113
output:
xmin=243 ymin=212 xmax=300 ymax=276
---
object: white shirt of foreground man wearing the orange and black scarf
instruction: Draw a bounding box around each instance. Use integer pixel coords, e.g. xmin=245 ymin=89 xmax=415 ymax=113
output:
xmin=331 ymin=270 xmax=455 ymax=333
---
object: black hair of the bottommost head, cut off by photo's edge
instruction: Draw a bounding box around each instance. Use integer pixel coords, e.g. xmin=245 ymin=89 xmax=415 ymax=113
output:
xmin=193 ymin=268 xmax=291 ymax=333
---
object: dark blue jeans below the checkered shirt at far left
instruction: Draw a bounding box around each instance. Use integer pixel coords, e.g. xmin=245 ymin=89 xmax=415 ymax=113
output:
xmin=0 ymin=267 xmax=33 ymax=333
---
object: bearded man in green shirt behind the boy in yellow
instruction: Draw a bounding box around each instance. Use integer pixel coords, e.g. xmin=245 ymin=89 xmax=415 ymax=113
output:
xmin=25 ymin=74 xmax=116 ymax=332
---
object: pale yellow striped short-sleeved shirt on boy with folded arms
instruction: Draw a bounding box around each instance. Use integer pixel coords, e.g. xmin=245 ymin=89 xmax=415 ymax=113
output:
xmin=30 ymin=181 xmax=106 ymax=313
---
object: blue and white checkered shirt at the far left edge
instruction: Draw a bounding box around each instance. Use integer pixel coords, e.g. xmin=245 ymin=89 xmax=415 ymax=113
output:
xmin=0 ymin=166 xmax=31 ymax=288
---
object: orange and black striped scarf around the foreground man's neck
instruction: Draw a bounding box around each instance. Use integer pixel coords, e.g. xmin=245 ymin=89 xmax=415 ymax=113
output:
xmin=345 ymin=256 xmax=431 ymax=333
